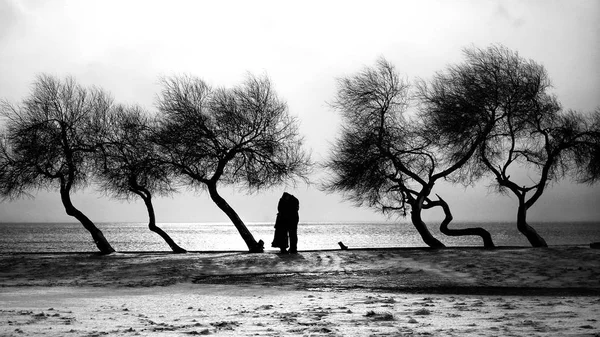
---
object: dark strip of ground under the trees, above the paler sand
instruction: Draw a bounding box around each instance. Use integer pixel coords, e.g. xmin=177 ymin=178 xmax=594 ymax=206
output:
xmin=0 ymin=246 xmax=600 ymax=296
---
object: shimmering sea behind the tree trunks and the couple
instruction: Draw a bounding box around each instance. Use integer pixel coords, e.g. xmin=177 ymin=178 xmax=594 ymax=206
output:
xmin=0 ymin=221 xmax=600 ymax=253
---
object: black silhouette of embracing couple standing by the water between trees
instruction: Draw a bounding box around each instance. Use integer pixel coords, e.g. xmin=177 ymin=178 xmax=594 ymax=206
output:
xmin=271 ymin=192 xmax=300 ymax=254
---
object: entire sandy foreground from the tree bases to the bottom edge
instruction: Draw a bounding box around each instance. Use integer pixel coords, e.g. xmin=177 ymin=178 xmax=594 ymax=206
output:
xmin=0 ymin=247 xmax=600 ymax=336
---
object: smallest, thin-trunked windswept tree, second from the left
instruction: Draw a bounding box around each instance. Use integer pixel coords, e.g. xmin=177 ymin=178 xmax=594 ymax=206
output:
xmin=95 ymin=105 xmax=186 ymax=253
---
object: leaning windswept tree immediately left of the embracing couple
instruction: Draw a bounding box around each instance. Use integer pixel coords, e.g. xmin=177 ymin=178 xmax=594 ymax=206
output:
xmin=157 ymin=75 xmax=310 ymax=252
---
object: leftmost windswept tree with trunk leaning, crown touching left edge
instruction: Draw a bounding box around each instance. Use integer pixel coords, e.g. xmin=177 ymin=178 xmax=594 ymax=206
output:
xmin=0 ymin=75 xmax=114 ymax=254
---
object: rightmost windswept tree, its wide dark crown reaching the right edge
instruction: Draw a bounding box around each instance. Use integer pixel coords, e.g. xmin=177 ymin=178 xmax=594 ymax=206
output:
xmin=420 ymin=46 xmax=600 ymax=247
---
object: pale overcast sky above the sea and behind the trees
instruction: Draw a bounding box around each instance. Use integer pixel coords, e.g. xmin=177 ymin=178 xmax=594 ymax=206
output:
xmin=0 ymin=0 xmax=600 ymax=222
